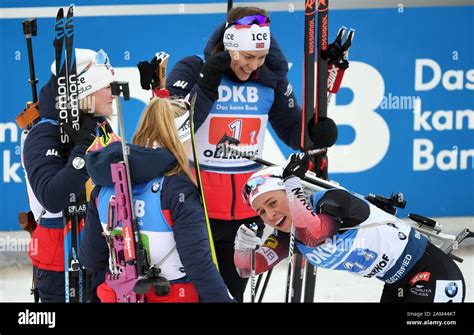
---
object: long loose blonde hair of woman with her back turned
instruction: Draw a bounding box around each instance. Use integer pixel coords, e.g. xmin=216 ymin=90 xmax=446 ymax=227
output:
xmin=132 ymin=98 xmax=195 ymax=184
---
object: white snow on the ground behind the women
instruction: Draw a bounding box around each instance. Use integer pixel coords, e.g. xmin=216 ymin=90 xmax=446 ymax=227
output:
xmin=0 ymin=217 xmax=474 ymax=302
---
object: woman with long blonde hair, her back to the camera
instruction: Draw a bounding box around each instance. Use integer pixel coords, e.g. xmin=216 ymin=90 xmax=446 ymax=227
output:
xmin=79 ymin=98 xmax=234 ymax=302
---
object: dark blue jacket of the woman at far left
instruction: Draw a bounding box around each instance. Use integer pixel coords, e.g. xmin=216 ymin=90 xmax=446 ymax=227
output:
xmin=23 ymin=75 xmax=89 ymax=213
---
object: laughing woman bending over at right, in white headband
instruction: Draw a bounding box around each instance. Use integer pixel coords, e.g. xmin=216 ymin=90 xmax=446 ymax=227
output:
xmin=234 ymin=154 xmax=466 ymax=302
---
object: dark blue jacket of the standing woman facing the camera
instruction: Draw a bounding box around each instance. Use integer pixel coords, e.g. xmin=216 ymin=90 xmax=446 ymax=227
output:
xmin=166 ymin=23 xmax=301 ymax=150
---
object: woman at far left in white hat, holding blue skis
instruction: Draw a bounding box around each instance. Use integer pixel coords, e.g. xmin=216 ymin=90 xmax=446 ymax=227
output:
xmin=23 ymin=49 xmax=115 ymax=302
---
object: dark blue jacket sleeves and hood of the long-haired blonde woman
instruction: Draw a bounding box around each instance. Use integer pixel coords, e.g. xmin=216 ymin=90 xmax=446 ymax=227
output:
xmin=79 ymin=142 xmax=232 ymax=302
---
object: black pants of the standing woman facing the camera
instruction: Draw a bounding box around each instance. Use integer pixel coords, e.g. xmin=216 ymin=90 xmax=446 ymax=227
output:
xmin=209 ymin=217 xmax=261 ymax=302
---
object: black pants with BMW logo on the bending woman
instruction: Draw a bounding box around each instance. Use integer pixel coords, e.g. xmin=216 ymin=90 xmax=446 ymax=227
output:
xmin=380 ymin=243 xmax=466 ymax=302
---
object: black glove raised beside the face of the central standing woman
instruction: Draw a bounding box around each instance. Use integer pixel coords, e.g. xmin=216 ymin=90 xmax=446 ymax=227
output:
xmin=197 ymin=51 xmax=231 ymax=100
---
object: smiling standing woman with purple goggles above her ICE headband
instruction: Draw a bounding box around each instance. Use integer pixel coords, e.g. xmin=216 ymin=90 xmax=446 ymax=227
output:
xmin=139 ymin=7 xmax=337 ymax=301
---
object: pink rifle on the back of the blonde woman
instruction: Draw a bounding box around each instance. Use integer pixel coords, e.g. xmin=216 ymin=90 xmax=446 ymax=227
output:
xmin=104 ymin=81 xmax=170 ymax=302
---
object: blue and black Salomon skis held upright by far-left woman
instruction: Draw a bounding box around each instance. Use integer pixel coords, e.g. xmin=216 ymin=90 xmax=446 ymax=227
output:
xmin=54 ymin=5 xmax=91 ymax=302
